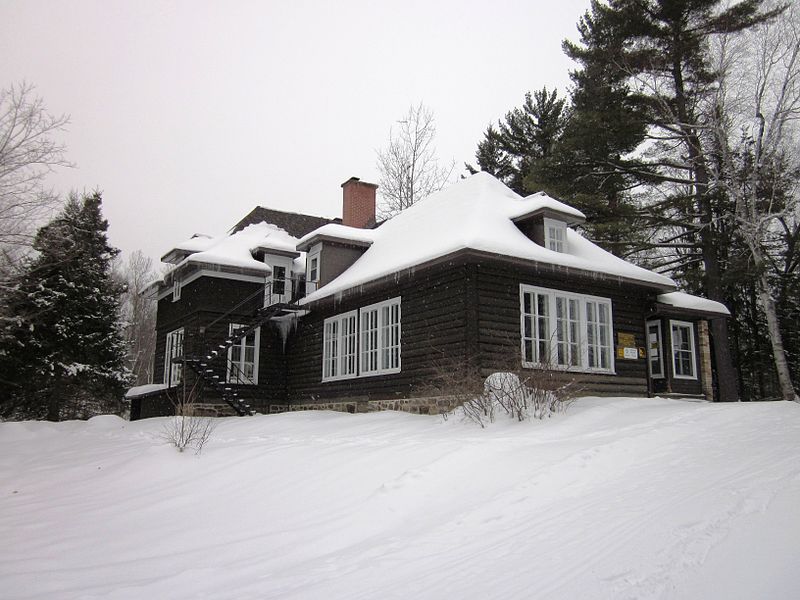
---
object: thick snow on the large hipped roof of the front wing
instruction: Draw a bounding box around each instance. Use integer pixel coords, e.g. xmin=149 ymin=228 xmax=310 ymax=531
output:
xmin=303 ymin=172 xmax=675 ymax=302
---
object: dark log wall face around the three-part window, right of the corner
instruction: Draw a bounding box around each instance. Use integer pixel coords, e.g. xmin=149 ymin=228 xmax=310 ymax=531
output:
xmin=474 ymin=261 xmax=653 ymax=396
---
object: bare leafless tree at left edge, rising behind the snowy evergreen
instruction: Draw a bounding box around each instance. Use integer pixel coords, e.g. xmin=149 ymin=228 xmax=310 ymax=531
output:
xmin=0 ymin=82 xmax=72 ymax=260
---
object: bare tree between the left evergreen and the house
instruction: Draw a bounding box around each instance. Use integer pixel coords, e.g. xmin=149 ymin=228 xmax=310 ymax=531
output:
xmin=122 ymin=250 xmax=158 ymax=385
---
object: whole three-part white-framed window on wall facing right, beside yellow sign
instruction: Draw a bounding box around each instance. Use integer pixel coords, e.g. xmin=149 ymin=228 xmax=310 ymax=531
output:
xmin=520 ymin=284 xmax=614 ymax=373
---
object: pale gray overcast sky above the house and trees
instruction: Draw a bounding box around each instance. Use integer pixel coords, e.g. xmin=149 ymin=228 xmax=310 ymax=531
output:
xmin=0 ymin=0 xmax=589 ymax=268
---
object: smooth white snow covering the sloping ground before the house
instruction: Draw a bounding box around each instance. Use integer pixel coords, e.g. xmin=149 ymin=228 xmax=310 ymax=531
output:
xmin=0 ymin=398 xmax=800 ymax=600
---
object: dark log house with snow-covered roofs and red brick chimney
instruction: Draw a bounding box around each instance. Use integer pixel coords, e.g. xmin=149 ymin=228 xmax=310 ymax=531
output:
xmin=128 ymin=173 xmax=728 ymax=418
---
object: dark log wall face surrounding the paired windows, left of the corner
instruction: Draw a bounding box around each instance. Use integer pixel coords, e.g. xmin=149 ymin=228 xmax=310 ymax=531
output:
xmin=287 ymin=261 xmax=468 ymax=403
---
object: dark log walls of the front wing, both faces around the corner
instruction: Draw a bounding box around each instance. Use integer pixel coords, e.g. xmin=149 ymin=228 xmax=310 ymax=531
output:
xmin=287 ymin=251 xmax=652 ymax=403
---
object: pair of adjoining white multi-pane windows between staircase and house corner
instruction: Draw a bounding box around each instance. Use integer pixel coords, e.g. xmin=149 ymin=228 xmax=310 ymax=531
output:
xmin=322 ymin=298 xmax=401 ymax=381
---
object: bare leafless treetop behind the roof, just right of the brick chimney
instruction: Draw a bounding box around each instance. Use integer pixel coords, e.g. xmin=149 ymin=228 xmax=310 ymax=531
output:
xmin=377 ymin=102 xmax=455 ymax=217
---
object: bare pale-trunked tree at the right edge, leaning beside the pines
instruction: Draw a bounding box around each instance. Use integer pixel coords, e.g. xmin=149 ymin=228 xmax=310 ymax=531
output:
xmin=712 ymin=6 xmax=800 ymax=401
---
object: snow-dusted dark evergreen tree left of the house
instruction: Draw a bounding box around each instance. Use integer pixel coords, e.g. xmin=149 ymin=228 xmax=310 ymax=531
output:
xmin=0 ymin=193 xmax=129 ymax=421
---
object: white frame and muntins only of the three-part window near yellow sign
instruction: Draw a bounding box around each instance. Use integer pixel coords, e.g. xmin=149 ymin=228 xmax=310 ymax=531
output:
xmin=519 ymin=283 xmax=616 ymax=375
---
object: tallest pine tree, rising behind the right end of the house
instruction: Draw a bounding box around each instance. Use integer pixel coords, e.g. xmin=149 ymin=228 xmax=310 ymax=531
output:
xmin=556 ymin=0 xmax=779 ymax=400
